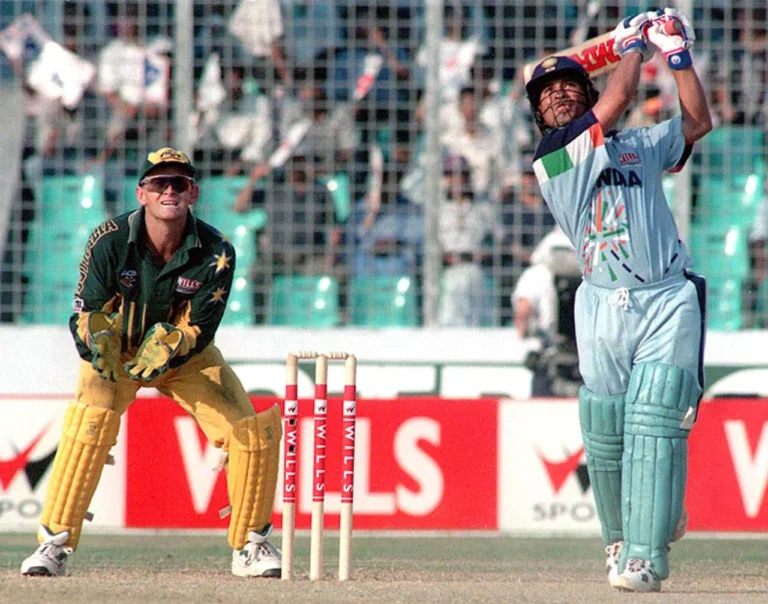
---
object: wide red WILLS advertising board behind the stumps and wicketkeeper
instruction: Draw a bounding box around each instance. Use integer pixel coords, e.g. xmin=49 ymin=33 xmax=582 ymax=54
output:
xmin=125 ymin=397 xmax=498 ymax=530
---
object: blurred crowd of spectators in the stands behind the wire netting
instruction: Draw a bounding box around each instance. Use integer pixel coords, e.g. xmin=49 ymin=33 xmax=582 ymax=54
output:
xmin=0 ymin=0 xmax=768 ymax=329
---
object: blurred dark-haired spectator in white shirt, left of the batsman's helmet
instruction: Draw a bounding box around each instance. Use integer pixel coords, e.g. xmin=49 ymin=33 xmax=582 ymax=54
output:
xmin=441 ymin=87 xmax=503 ymax=199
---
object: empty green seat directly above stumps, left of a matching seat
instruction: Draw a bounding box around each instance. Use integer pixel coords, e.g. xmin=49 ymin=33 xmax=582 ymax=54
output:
xmin=268 ymin=275 xmax=339 ymax=328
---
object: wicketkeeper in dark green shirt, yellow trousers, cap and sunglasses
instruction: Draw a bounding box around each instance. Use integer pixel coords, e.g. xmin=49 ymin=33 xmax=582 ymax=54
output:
xmin=21 ymin=147 xmax=282 ymax=577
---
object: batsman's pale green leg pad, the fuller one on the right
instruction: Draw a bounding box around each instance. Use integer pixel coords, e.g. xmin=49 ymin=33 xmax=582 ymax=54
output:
xmin=619 ymin=363 xmax=699 ymax=579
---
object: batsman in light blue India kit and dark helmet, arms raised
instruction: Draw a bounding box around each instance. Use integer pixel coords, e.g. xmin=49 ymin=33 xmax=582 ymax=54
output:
xmin=526 ymin=9 xmax=712 ymax=592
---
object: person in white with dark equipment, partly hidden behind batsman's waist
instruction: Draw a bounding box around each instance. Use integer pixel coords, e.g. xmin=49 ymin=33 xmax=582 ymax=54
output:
xmin=512 ymin=227 xmax=581 ymax=397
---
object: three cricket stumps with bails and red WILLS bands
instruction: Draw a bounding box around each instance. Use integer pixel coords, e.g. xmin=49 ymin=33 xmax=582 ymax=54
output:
xmin=282 ymin=351 xmax=357 ymax=581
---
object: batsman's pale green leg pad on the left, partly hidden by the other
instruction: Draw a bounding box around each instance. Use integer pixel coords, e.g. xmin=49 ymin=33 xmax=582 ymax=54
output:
xmin=579 ymin=386 xmax=624 ymax=545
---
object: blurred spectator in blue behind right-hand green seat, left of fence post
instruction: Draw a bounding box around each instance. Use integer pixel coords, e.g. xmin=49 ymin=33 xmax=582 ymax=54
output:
xmin=348 ymin=149 xmax=424 ymax=276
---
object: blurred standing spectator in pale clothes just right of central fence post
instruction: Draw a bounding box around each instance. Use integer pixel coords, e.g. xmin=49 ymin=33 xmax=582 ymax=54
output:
xmin=438 ymin=155 xmax=493 ymax=327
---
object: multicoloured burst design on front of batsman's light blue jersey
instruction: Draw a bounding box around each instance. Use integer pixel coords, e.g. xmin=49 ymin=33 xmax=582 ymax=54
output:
xmin=581 ymin=189 xmax=632 ymax=281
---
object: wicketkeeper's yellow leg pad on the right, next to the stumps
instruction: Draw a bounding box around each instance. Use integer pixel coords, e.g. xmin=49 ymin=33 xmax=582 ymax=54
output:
xmin=227 ymin=405 xmax=283 ymax=550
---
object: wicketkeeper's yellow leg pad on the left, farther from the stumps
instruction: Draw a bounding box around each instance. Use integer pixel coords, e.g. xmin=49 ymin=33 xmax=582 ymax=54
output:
xmin=38 ymin=403 xmax=120 ymax=549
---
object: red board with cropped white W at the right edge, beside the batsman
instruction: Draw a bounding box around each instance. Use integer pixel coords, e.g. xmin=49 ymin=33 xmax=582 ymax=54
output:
xmin=686 ymin=399 xmax=768 ymax=531
